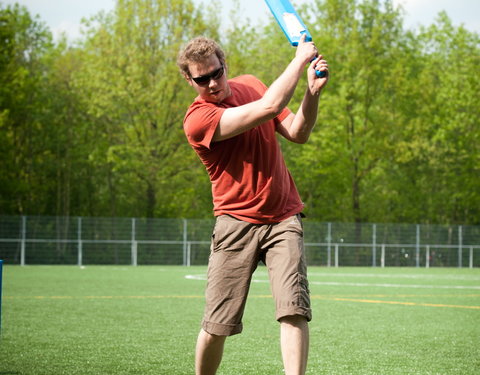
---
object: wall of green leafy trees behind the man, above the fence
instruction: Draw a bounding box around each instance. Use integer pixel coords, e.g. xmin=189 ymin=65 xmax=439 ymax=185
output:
xmin=0 ymin=0 xmax=480 ymax=224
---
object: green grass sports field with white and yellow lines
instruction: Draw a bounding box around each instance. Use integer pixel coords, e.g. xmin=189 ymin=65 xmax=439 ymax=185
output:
xmin=0 ymin=266 xmax=480 ymax=375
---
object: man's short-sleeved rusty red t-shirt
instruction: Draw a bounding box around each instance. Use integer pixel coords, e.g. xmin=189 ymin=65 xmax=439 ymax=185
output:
xmin=183 ymin=75 xmax=303 ymax=224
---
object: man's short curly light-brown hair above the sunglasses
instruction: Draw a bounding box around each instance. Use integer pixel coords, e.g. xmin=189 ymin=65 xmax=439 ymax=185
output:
xmin=177 ymin=36 xmax=225 ymax=77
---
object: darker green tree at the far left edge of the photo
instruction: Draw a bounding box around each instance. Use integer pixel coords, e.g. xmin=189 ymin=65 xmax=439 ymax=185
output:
xmin=0 ymin=4 xmax=53 ymax=213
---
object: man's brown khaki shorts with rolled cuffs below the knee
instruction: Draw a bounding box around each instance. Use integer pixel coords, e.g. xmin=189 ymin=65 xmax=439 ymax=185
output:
xmin=202 ymin=215 xmax=312 ymax=336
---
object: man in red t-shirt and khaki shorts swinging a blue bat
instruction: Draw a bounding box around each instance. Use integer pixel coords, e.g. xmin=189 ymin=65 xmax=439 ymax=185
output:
xmin=177 ymin=37 xmax=328 ymax=375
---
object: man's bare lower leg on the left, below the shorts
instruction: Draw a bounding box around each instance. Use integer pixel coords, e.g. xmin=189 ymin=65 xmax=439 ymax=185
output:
xmin=195 ymin=329 xmax=227 ymax=375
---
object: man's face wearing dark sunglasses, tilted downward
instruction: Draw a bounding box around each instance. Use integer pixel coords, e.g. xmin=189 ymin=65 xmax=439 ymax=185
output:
xmin=187 ymin=55 xmax=230 ymax=103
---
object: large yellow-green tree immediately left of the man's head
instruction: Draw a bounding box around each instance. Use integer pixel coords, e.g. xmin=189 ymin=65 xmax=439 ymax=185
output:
xmin=75 ymin=0 xmax=218 ymax=217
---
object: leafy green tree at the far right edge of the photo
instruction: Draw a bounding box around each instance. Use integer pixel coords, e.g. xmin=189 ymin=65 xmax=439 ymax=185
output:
xmin=394 ymin=13 xmax=480 ymax=224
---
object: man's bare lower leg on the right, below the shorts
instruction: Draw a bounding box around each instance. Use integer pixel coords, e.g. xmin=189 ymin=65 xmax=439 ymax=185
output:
xmin=280 ymin=315 xmax=309 ymax=375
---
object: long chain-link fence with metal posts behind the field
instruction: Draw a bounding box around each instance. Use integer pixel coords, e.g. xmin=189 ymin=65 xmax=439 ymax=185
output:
xmin=0 ymin=216 xmax=480 ymax=268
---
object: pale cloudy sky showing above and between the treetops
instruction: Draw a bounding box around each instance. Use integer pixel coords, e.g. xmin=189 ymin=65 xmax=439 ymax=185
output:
xmin=0 ymin=0 xmax=480 ymax=40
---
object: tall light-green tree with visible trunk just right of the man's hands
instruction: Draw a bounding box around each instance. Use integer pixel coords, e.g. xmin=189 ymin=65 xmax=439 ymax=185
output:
xmin=284 ymin=0 xmax=403 ymax=223
